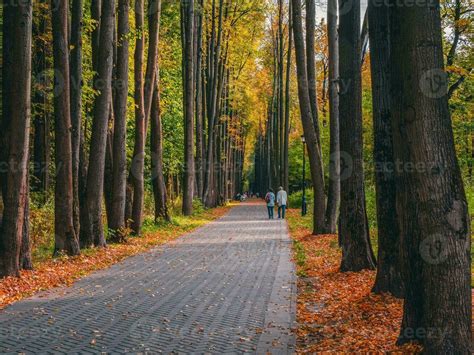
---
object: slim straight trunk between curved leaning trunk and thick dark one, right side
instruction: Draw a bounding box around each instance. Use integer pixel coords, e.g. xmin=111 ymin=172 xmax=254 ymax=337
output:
xmin=325 ymin=0 xmax=341 ymax=234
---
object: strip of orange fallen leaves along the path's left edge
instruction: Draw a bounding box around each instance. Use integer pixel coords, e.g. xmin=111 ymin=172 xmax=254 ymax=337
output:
xmin=0 ymin=207 xmax=229 ymax=309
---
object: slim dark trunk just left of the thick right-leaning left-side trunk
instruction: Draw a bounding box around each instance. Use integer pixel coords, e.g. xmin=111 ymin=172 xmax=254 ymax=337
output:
xmin=70 ymin=0 xmax=83 ymax=241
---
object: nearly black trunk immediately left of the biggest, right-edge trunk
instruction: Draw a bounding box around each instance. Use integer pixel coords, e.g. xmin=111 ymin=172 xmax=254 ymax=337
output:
xmin=368 ymin=0 xmax=403 ymax=297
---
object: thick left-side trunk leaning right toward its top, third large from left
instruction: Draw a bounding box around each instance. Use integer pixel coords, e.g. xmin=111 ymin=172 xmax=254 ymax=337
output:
xmin=81 ymin=0 xmax=115 ymax=247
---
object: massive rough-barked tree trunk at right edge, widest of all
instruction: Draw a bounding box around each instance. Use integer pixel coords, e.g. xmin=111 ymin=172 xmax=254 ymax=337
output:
xmin=390 ymin=1 xmax=472 ymax=354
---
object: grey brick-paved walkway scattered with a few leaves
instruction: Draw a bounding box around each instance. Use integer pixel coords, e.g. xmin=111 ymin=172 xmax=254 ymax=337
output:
xmin=0 ymin=204 xmax=296 ymax=354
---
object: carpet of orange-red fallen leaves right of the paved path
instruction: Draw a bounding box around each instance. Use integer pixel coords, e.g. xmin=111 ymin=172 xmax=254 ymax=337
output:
xmin=289 ymin=210 xmax=421 ymax=353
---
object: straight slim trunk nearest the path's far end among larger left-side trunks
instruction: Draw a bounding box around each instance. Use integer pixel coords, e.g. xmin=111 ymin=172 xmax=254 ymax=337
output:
xmin=181 ymin=0 xmax=195 ymax=216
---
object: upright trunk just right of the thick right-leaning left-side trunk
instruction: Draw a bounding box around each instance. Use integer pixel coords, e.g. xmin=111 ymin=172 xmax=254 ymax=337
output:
xmin=108 ymin=0 xmax=130 ymax=241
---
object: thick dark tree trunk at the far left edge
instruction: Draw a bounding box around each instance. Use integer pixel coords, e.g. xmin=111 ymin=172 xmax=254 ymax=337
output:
xmin=0 ymin=0 xmax=33 ymax=277
